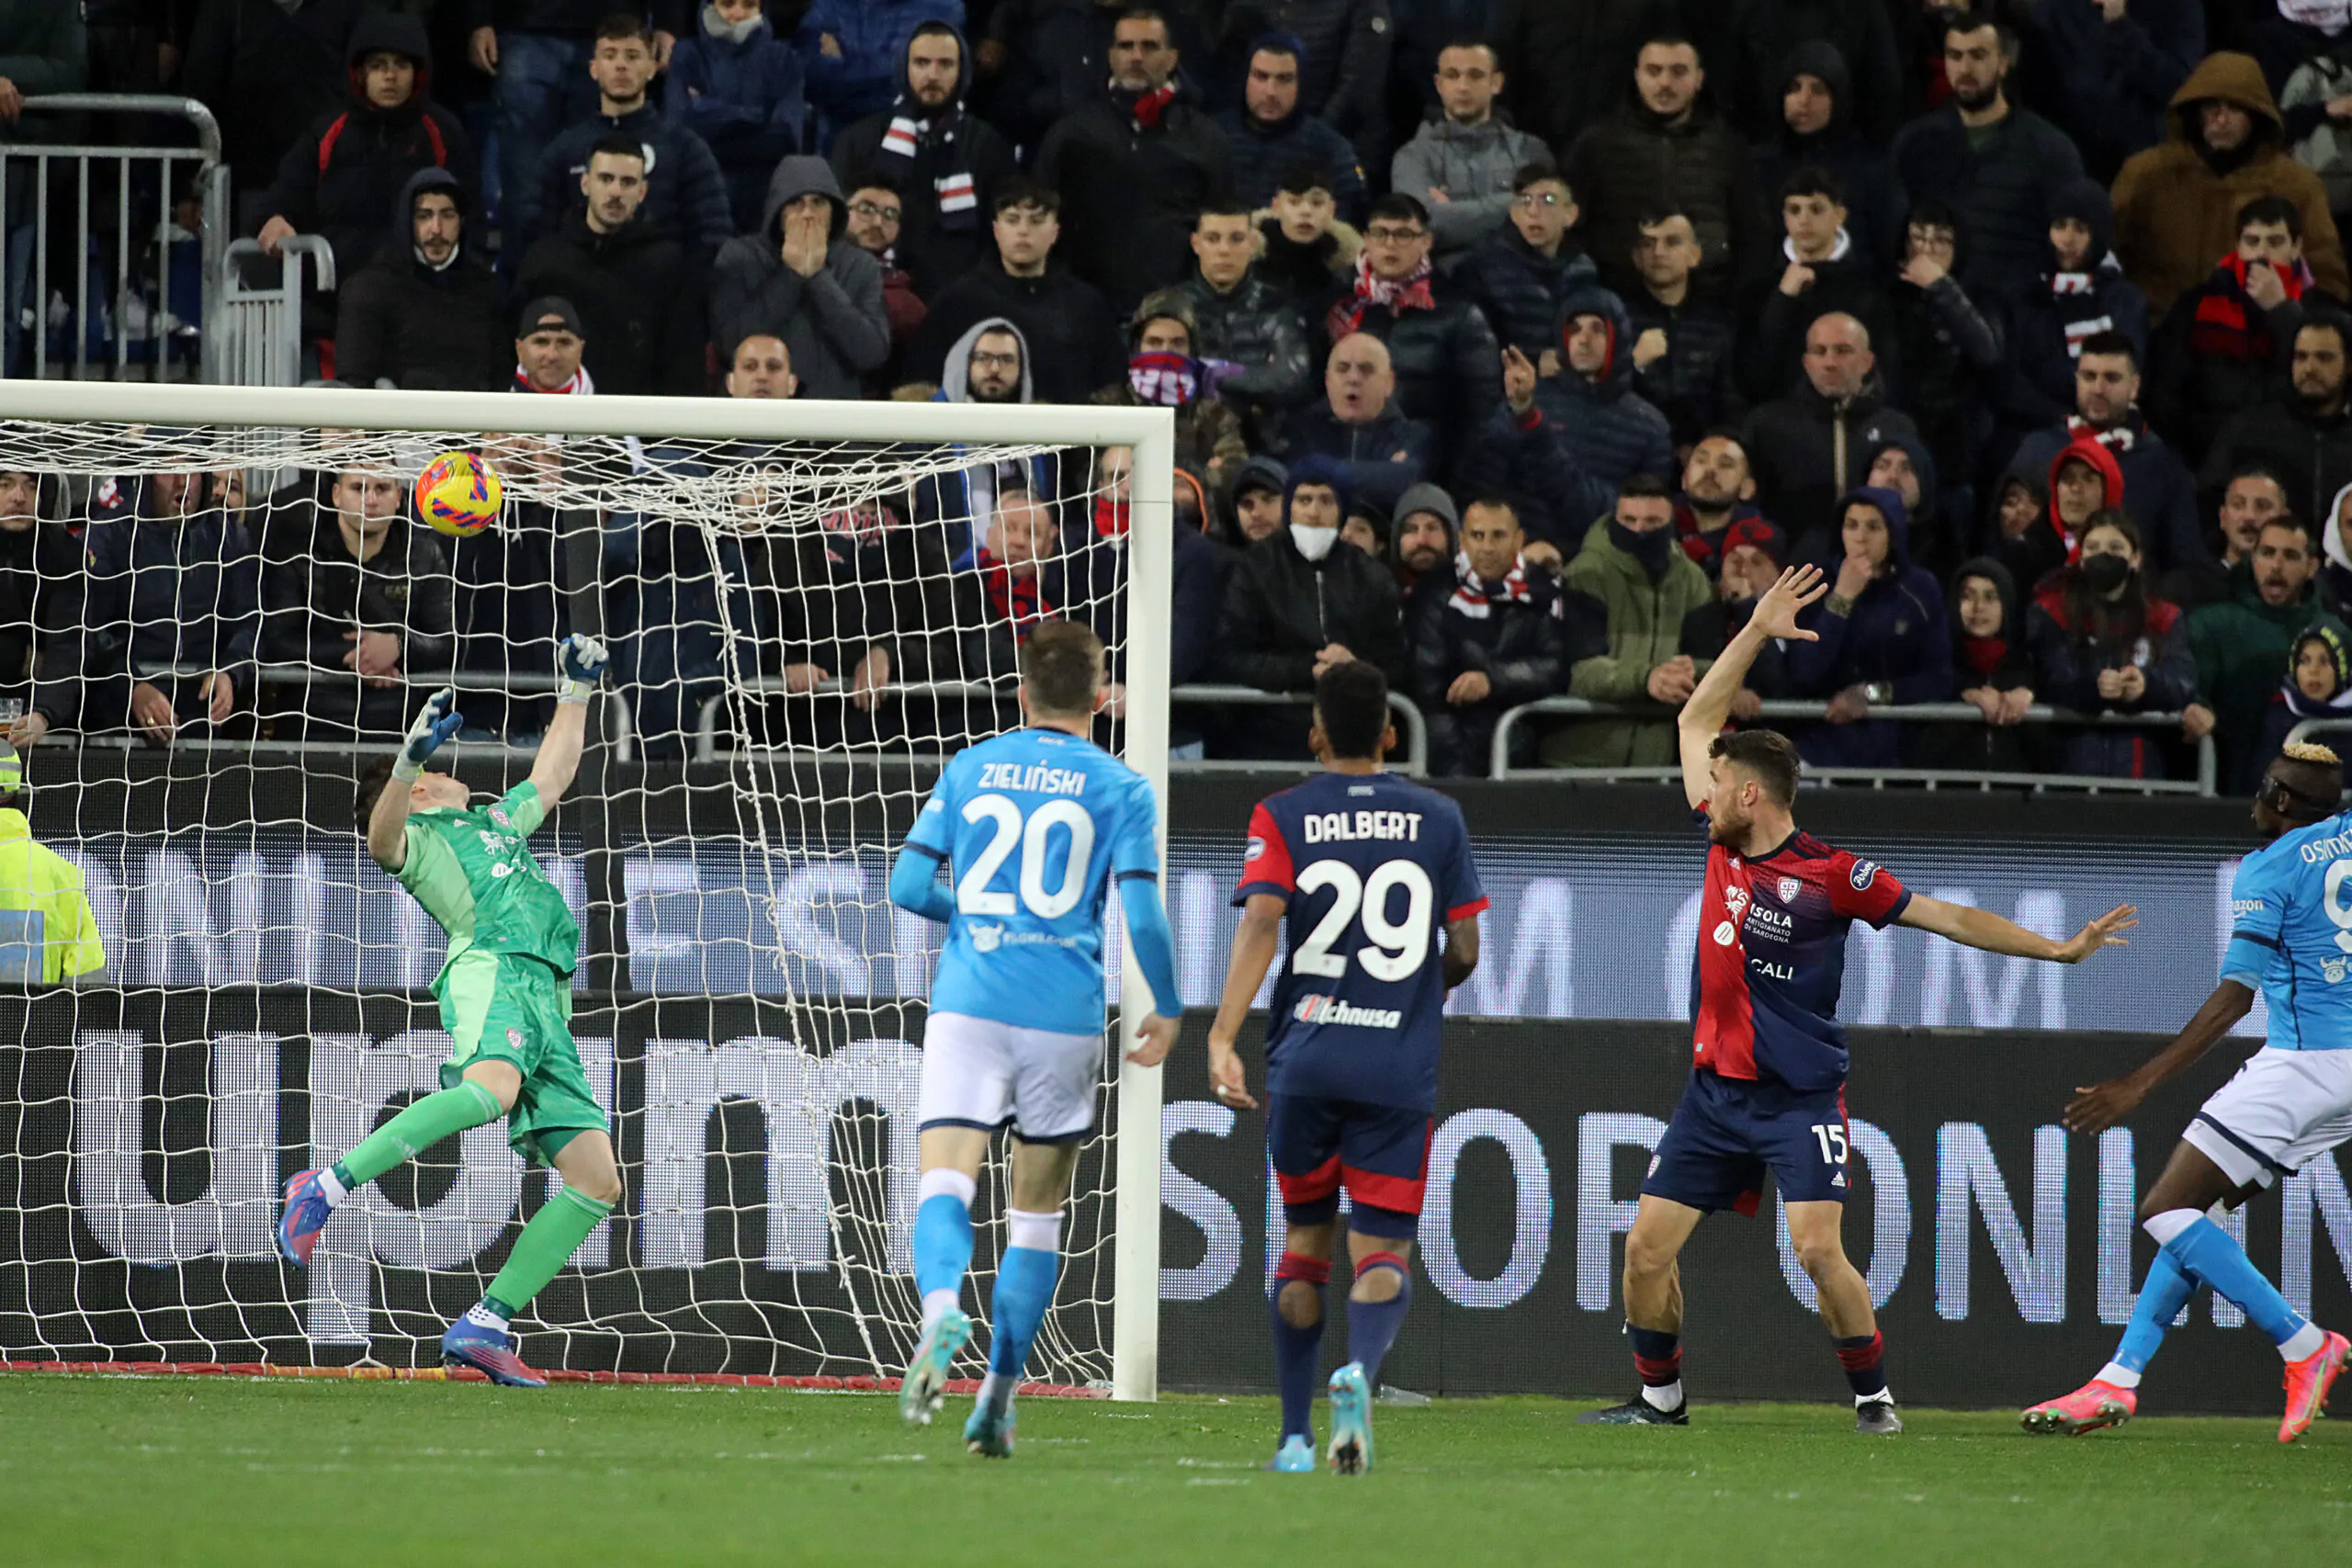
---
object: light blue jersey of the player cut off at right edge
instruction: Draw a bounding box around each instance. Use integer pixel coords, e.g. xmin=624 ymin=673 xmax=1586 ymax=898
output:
xmin=2221 ymin=813 xmax=2352 ymax=1051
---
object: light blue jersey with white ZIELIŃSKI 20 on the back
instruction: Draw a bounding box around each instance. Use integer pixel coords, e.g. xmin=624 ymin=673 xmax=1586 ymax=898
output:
xmin=906 ymin=728 xmax=1159 ymax=1034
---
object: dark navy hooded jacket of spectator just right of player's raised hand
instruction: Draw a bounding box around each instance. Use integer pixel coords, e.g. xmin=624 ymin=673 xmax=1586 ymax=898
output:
xmin=1785 ymin=484 xmax=1952 ymax=769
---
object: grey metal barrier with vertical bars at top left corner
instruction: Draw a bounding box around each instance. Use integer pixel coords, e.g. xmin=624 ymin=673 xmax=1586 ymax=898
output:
xmin=0 ymin=92 xmax=224 ymax=381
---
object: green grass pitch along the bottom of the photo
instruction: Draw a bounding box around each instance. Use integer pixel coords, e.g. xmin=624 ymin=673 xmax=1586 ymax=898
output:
xmin=0 ymin=1373 xmax=2352 ymax=1568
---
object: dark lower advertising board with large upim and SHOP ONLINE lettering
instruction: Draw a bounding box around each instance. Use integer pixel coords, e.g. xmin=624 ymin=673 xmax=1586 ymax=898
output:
xmin=0 ymin=989 xmax=2352 ymax=1420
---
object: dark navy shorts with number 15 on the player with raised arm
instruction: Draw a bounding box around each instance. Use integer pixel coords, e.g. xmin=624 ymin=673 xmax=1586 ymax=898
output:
xmin=1642 ymin=1067 xmax=1853 ymax=1213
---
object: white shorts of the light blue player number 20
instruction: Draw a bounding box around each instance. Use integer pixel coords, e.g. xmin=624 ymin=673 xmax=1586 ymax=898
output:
xmin=917 ymin=1013 xmax=1103 ymax=1143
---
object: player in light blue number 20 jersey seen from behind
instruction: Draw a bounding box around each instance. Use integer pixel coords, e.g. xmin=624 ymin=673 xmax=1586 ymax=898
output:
xmin=889 ymin=621 xmax=1183 ymax=1458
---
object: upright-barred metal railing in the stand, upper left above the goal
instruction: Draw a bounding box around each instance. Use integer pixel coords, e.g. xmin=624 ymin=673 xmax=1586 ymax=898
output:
xmin=0 ymin=92 xmax=231 ymax=381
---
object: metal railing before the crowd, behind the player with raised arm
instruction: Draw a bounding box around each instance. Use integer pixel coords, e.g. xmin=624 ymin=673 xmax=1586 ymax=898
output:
xmin=1487 ymin=696 xmax=2220 ymax=797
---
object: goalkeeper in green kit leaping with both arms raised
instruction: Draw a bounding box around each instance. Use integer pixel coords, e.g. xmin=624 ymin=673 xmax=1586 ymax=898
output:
xmin=277 ymin=637 xmax=621 ymax=1389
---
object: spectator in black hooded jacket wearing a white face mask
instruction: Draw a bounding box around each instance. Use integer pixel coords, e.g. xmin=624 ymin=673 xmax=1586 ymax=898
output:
xmin=1216 ymin=456 xmax=1404 ymax=757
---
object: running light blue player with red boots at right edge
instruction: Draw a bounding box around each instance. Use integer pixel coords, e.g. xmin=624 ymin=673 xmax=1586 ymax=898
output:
xmin=2023 ymin=743 xmax=2352 ymax=1443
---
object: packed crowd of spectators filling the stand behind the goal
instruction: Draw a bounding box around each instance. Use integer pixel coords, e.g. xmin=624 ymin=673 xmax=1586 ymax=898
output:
xmin=0 ymin=0 xmax=2352 ymax=787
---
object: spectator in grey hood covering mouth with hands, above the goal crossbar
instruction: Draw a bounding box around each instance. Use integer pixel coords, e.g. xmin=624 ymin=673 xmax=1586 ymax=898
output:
xmin=710 ymin=155 xmax=889 ymax=398
